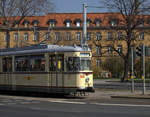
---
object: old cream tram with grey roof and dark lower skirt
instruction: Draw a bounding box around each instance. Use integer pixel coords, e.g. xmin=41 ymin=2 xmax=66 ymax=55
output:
xmin=0 ymin=45 xmax=94 ymax=94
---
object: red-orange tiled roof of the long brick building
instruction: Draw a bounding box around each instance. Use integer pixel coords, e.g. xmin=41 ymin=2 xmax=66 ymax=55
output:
xmin=0 ymin=13 xmax=150 ymax=27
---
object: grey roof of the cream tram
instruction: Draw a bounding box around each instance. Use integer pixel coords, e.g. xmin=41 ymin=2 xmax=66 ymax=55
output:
xmin=0 ymin=45 xmax=90 ymax=56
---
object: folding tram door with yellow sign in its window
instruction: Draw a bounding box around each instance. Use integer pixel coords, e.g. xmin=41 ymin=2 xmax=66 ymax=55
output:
xmin=49 ymin=54 xmax=64 ymax=91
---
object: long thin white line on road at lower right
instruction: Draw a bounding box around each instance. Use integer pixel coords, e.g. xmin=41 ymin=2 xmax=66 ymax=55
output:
xmin=90 ymin=103 xmax=150 ymax=108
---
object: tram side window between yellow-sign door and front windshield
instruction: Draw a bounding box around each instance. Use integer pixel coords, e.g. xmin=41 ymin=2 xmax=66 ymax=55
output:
xmin=66 ymin=57 xmax=80 ymax=71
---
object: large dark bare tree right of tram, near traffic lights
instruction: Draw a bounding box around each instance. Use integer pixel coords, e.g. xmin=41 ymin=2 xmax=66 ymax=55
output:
xmin=101 ymin=0 xmax=150 ymax=82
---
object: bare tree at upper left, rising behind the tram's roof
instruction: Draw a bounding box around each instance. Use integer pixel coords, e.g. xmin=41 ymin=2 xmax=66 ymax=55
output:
xmin=0 ymin=0 xmax=54 ymax=48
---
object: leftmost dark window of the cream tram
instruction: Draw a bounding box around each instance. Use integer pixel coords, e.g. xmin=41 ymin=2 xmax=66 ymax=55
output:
xmin=2 ymin=57 xmax=12 ymax=72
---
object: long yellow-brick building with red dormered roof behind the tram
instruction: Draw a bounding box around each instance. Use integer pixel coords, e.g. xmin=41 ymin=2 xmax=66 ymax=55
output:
xmin=0 ymin=13 xmax=150 ymax=77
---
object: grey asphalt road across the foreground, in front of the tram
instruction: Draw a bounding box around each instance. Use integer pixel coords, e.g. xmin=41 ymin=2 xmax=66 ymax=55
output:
xmin=0 ymin=96 xmax=150 ymax=117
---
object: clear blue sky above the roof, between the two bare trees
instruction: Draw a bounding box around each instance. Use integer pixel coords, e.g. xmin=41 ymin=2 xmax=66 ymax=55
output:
xmin=52 ymin=0 xmax=105 ymax=13
